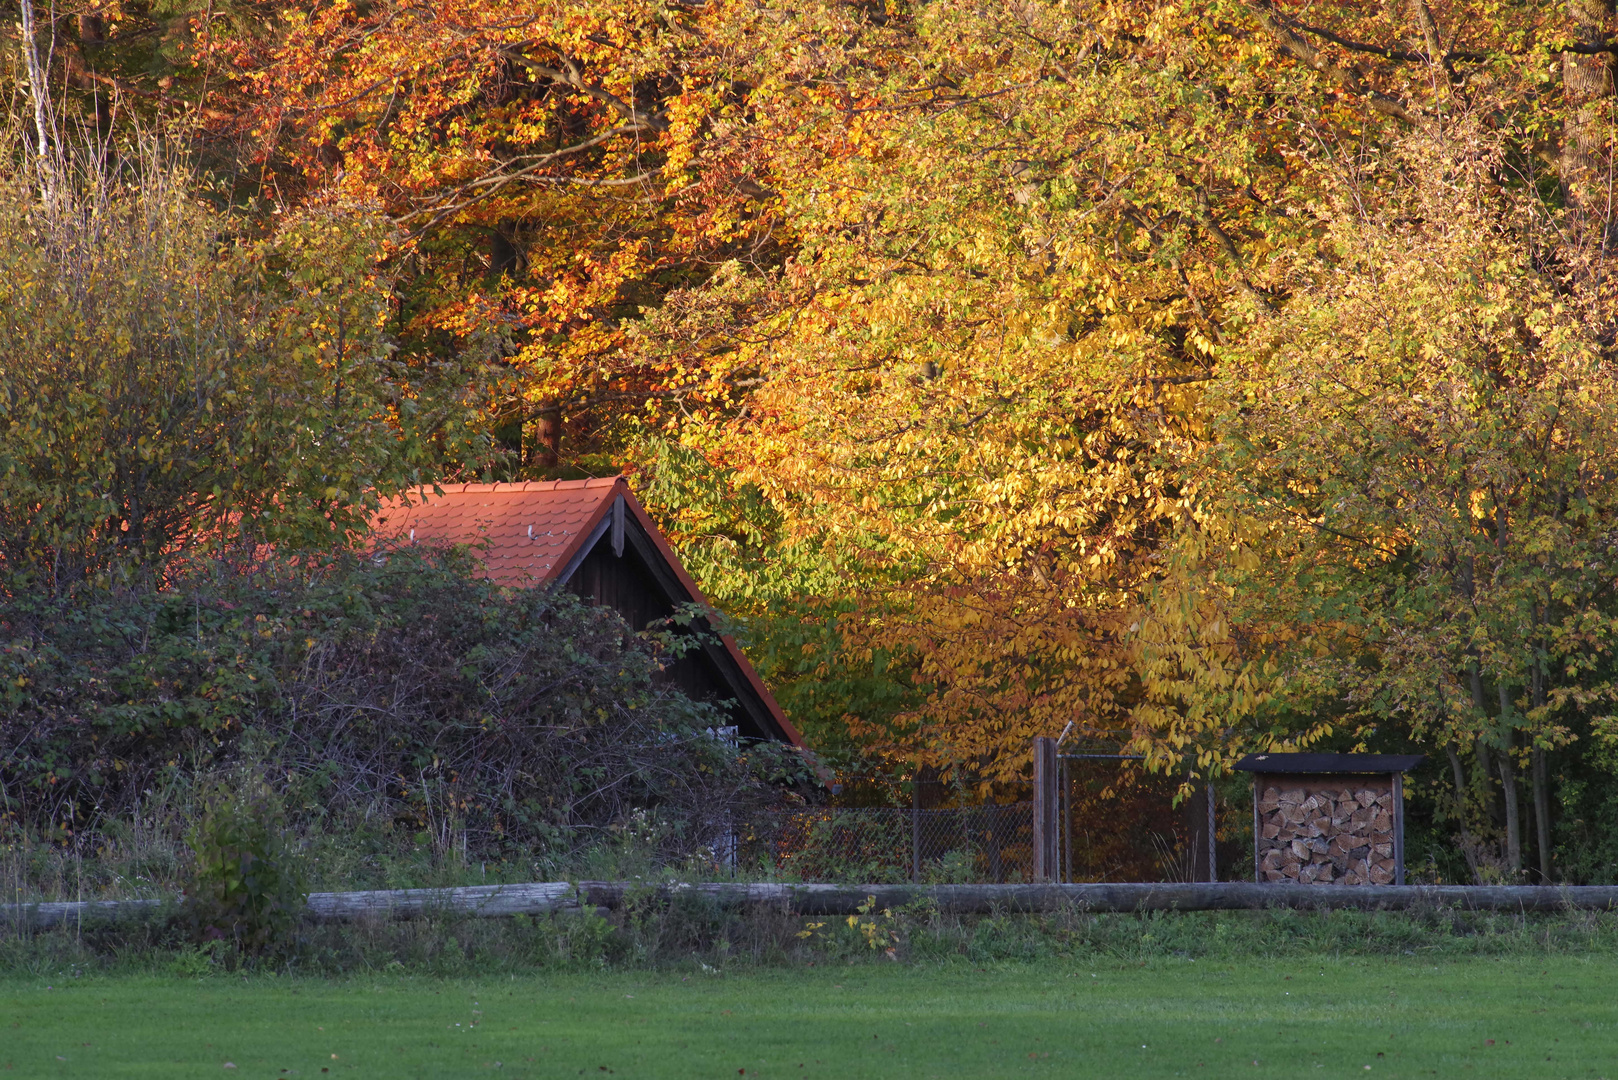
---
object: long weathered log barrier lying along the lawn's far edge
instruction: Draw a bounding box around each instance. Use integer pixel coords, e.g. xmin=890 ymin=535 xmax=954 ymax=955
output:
xmin=0 ymin=881 xmax=1618 ymax=929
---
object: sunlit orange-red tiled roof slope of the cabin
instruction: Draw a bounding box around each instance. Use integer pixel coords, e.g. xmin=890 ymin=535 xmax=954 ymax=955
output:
xmin=374 ymin=476 xmax=629 ymax=585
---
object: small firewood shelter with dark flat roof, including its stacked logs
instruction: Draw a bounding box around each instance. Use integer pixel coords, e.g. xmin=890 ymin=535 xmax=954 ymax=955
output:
xmin=1236 ymin=753 xmax=1424 ymax=886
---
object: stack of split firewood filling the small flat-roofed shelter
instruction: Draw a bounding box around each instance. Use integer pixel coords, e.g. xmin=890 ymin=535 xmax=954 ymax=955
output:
xmin=1257 ymin=782 xmax=1395 ymax=886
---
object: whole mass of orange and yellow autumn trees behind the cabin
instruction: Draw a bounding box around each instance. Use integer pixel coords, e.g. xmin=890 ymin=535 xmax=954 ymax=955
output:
xmin=15 ymin=0 xmax=1618 ymax=873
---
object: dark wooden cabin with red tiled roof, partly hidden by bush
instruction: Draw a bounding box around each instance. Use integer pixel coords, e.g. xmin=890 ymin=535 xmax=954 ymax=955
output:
xmin=374 ymin=476 xmax=803 ymax=746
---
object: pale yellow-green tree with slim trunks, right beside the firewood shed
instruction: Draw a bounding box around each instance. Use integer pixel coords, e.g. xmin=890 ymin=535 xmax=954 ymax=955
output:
xmin=1147 ymin=111 xmax=1618 ymax=881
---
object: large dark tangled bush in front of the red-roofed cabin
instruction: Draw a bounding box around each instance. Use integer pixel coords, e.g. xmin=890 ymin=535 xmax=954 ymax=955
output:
xmin=0 ymin=549 xmax=809 ymax=858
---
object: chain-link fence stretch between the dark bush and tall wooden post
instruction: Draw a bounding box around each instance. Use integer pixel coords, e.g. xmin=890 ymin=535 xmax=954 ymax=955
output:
xmin=736 ymin=803 xmax=1034 ymax=884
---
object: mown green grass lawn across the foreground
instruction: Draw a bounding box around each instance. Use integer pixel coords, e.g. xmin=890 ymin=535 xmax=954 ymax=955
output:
xmin=0 ymin=957 xmax=1618 ymax=1080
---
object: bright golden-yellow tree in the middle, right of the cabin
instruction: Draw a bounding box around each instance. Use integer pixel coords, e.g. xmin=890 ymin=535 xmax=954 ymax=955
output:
xmin=621 ymin=5 xmax=1404 ymax=780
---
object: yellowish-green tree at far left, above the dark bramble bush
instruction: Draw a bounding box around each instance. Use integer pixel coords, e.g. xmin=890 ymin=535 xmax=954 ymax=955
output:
xmin=0 ymin=139 xmax=464 ymax=594
